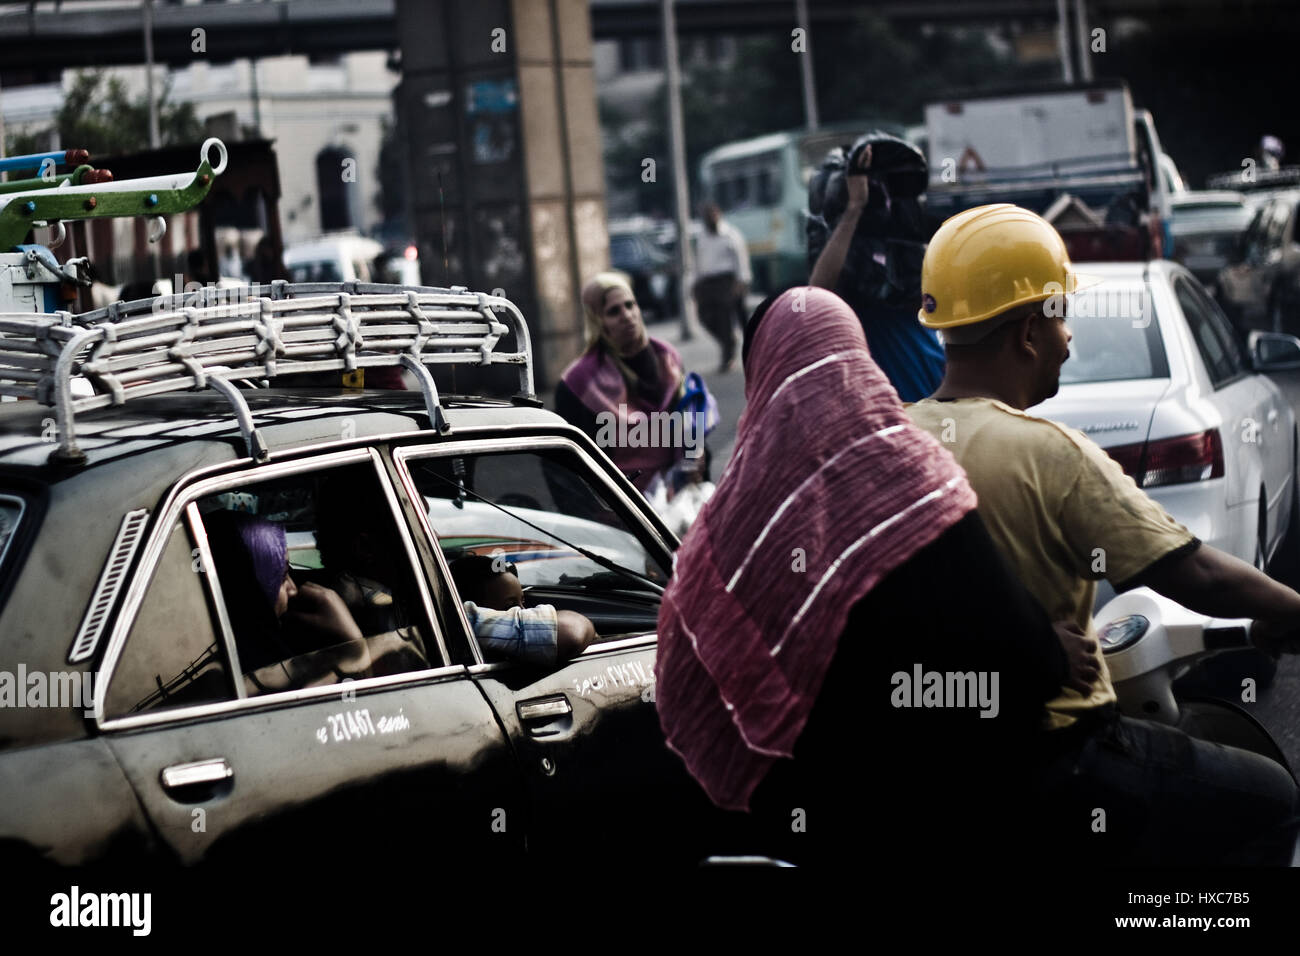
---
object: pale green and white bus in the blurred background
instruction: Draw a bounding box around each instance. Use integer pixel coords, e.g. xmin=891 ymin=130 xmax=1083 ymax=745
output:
xmin=699 ymin=120 xmax=904 ymax=294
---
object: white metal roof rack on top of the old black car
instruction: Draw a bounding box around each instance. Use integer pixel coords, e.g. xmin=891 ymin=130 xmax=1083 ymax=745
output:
xmin=0 ymin=280 xmax=536 ymax=463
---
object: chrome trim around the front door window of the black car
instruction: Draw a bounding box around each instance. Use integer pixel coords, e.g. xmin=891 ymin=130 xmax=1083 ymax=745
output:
xmin=393 ymin=436 xmax=673 ymax=666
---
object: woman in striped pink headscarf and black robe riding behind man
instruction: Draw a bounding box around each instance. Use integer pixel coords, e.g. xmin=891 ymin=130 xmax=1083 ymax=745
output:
xmin=655 ymin=287 xmax=1066 ymax=862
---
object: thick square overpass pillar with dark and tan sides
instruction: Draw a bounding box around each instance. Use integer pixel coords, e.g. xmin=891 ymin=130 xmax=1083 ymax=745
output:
xmin=397 ymin=0 xmax=608 ymax=385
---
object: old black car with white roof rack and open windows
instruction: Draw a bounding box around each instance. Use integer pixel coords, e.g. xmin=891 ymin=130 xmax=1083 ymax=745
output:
xmin=0 ymin=284 xmax=759 ymax=871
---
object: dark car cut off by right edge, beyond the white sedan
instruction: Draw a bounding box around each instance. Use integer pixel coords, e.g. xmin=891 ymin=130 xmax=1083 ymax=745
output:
xmin=1217 ymin=190 xmax=1300 ymax=334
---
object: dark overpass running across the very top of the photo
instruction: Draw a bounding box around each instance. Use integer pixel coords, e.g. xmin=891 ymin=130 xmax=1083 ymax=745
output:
xmin=0 ymin=0 xmax=1300 ymax=73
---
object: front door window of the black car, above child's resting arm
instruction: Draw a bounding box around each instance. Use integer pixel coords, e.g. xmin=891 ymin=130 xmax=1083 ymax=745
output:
xmin=408 ymin=449 xmax=671 ymax=650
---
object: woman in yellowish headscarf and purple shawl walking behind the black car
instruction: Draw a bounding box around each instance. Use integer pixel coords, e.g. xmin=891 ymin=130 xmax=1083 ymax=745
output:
xmin=555 ymin=272 xmax=718 ymax=494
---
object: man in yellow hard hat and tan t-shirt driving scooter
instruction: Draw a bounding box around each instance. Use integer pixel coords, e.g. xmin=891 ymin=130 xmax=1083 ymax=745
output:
xmin=907 ymin=203 xmax=1300 ymax=865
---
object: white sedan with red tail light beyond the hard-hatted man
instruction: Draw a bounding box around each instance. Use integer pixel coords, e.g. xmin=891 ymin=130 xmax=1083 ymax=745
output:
xmin=1030 ymin=260 xmax=1300 ymax=606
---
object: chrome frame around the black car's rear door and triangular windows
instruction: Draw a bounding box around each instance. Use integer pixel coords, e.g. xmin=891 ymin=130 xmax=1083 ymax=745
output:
xmin=94 ymin=447 xmax=459 ymax=731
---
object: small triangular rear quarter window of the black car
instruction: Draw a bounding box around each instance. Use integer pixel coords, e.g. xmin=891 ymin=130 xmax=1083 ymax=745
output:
xmin=104 ymin=522 xmax=234 ymax=717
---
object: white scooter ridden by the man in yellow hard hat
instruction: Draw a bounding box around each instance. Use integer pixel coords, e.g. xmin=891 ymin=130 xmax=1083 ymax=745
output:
xmin=1093 ymin=588 xmax=1295 ymax=777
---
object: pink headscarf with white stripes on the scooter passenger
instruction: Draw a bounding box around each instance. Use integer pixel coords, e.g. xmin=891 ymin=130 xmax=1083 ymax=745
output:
xmin=655 ymin=287 xmax=975 ymax=810
